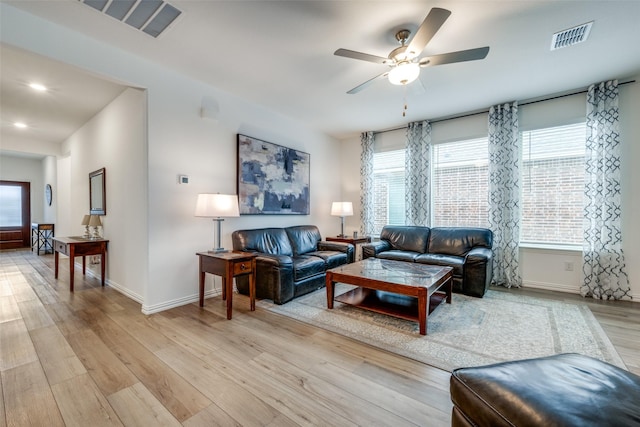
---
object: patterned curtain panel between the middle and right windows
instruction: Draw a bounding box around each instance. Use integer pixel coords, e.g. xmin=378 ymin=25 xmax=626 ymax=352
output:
xmin=489 ymin=102 xmax=522 ymax=288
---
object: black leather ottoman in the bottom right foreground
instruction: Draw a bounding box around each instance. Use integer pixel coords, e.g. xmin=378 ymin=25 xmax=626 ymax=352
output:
xmin=450 ymin=354 xmax=640 ymax=427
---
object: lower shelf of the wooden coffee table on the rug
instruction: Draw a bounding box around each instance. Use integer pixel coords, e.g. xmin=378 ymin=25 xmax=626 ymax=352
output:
xmin=334 ymin=287 xmax=447 ymax=322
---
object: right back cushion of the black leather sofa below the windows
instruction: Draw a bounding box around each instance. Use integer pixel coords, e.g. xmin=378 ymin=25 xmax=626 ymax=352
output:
xmin=425 ymin=227 xmax=493 ymax=257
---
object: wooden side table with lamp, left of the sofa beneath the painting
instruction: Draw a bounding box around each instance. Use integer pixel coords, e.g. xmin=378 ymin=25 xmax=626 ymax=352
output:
xmin=196 ymin=252 xmax=256 ymax=320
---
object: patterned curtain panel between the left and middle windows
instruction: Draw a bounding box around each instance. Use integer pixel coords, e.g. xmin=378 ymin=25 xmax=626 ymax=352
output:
xmin=405 ymin=120 xmax=431 ymax=226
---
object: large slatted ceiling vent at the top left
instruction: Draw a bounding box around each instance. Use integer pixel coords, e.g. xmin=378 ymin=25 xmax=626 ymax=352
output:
xmin=79 ymin=0 xmax=182 ymax=37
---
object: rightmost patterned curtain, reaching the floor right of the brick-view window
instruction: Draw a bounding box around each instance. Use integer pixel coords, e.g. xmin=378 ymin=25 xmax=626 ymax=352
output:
xmin=580 ymin=80 xmax=631 ymax=299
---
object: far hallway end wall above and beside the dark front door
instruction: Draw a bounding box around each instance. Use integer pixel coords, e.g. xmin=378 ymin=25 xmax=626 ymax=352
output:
xmin=0 ymin=155 xmax=44 ymax=223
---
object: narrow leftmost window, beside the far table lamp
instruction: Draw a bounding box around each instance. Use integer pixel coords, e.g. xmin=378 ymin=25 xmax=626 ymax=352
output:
xmin=373 ymin=150 xmax=405 ymax=235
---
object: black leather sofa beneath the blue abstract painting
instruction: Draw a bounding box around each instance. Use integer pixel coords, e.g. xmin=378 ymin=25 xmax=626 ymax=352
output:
xmin=231 ymin=225 xmax=354 ymax=304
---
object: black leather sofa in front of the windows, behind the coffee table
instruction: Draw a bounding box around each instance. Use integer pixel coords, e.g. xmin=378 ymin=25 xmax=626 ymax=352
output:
xmin=362 ymin=225 xmax=493 ymax=297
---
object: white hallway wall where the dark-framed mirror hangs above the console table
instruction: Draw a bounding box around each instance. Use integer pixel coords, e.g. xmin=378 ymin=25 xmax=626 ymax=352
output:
xmin=56 ymin=88 xmax=147 ymax=303
